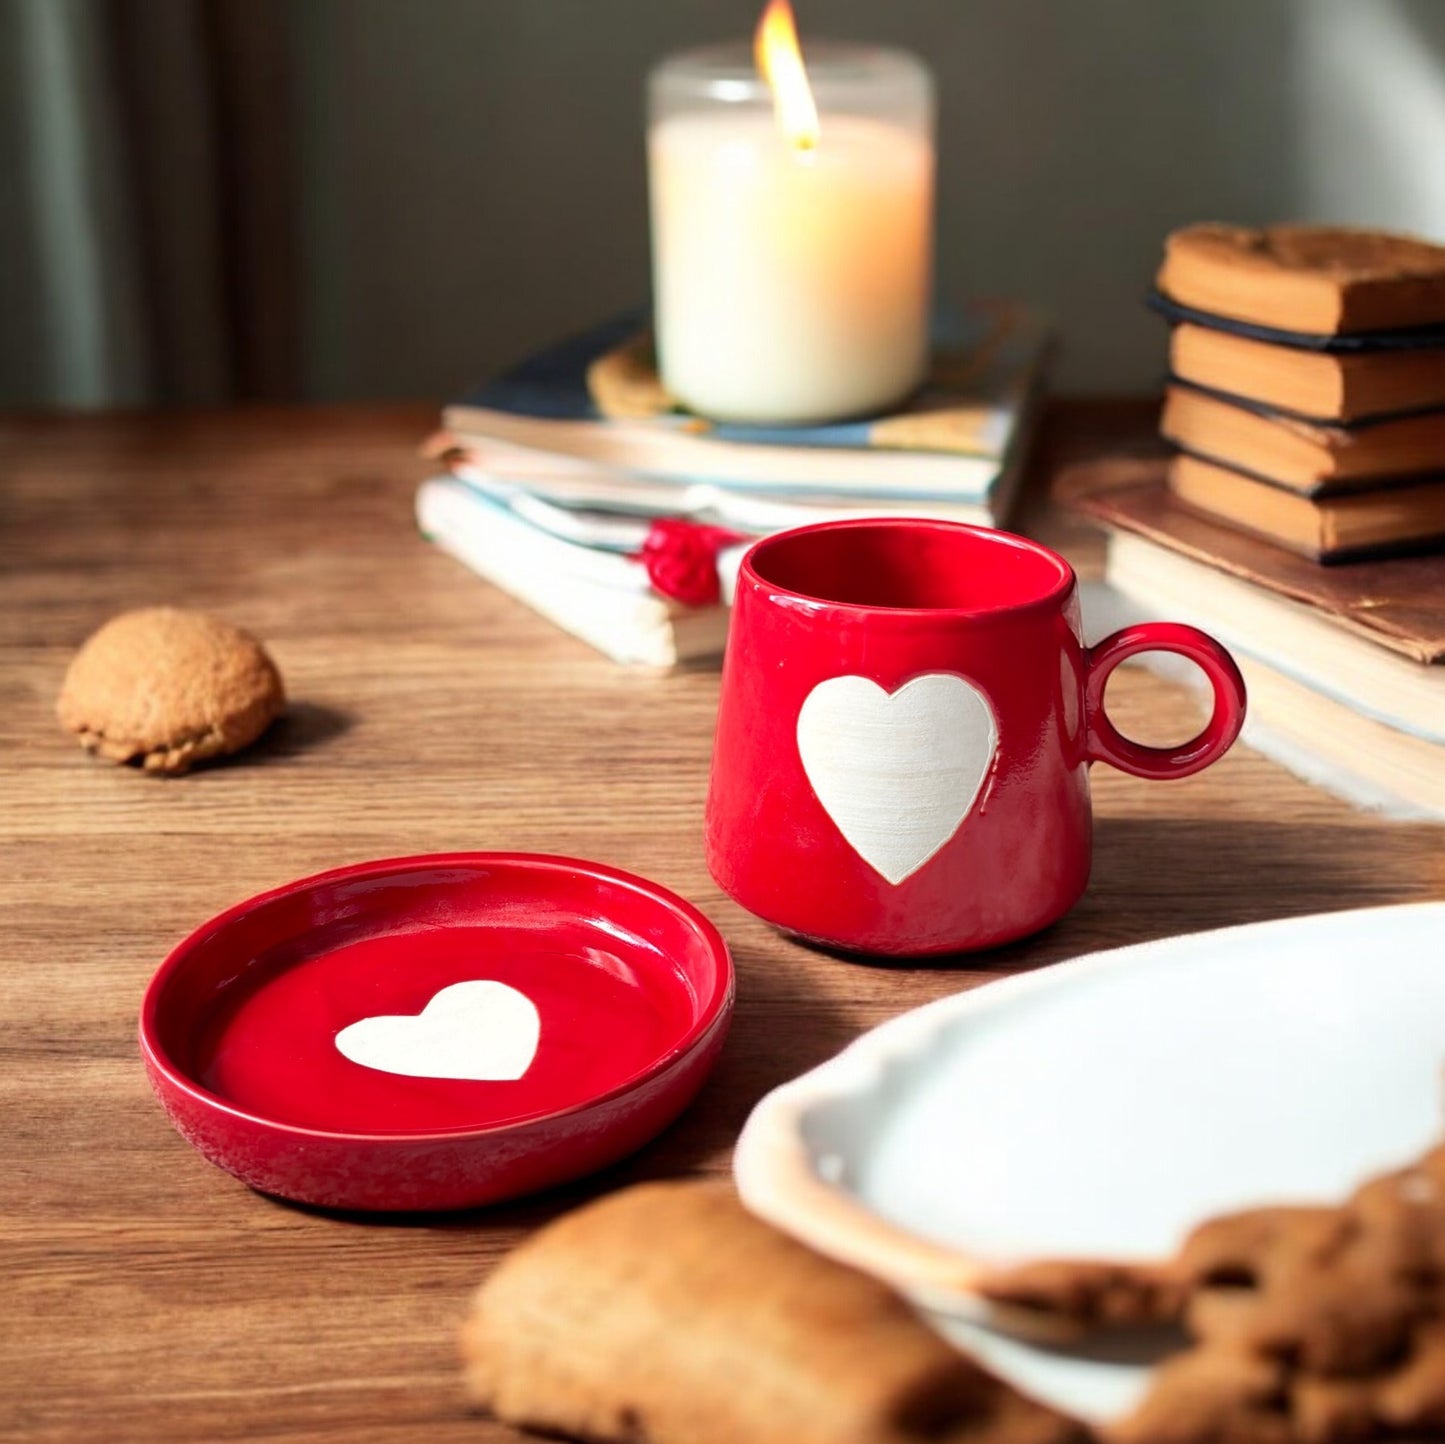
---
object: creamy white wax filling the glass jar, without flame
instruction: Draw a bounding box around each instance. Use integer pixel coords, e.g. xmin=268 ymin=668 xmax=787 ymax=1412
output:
xmin=649 ymin=110 xmax=933 ymax=424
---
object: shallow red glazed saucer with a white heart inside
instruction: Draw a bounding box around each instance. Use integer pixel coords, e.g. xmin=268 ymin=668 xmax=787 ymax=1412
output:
xmin=140 ymin=853 xmax=733 ymax=1210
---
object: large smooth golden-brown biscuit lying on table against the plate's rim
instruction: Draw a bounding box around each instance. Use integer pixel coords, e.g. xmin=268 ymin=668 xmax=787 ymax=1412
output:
xmin=462 ymin=1182 xmax=1085 ymax=1444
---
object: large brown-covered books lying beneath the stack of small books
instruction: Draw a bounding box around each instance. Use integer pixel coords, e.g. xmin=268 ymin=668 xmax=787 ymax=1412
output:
xmin=1066 ymin=465 xmax=1445 ymax=817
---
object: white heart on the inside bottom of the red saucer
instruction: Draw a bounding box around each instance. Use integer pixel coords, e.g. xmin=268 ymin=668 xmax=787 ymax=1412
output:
xmin=337 ymin=980 xmax=542 ymax=1083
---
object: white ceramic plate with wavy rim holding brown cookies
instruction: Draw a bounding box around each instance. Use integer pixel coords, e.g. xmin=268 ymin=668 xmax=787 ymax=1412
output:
xmin=734 ymin=903 xmax=1445 ymax=1419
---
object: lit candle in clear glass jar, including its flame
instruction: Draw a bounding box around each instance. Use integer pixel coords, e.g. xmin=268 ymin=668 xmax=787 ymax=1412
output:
xmin=649 ymin=0 xmax=933 ymax=424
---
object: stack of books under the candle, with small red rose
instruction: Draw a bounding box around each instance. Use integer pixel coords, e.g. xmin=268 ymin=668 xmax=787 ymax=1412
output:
xmin=416 ymin=302 xmax=1049 ymax=666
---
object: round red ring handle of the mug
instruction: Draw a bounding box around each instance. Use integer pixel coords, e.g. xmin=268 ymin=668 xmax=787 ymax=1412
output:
xmin=1084 ymin=622 xmax=1244 ymax=782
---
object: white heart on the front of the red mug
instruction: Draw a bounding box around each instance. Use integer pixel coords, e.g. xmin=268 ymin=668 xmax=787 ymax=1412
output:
xmin=798 ymin=672 xmax=998 ymax=886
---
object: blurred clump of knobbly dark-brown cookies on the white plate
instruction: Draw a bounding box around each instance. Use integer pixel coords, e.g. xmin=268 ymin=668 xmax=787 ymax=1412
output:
xmin=1105 ymin=1149 xmax=1445 ymax=1444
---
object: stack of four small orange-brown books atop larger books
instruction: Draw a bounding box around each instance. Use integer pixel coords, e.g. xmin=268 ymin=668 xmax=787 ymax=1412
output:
xmin=1153 ymin=225 xmax=1445 ymax=562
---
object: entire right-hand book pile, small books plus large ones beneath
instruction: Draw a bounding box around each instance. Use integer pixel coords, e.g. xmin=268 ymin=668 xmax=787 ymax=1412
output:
xmin=1059 ymin=225 xmax=1445 ymax=815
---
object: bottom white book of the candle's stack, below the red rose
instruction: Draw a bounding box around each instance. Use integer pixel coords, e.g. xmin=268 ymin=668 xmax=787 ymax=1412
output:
xmin=416 ymin=477 xmax=728 ymax=668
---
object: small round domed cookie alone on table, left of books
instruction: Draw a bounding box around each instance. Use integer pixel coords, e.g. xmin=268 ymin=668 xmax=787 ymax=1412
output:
xmin=56 ymin=607 xmax=286 ymax=773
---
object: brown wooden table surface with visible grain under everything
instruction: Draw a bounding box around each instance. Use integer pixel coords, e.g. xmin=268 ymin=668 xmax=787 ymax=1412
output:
xmin=0 ymin=405 xmax=1445 ymax=1441
